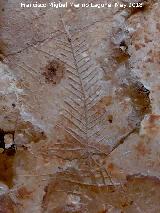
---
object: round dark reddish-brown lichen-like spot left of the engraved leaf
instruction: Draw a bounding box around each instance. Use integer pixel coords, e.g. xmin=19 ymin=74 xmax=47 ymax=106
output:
xmin=42 ymin=60 xmax=64 ymax=85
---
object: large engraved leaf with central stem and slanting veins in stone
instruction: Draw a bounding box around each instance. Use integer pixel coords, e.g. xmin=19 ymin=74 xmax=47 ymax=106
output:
xmin=61 ymin=20 xmax=106 ymax=142
